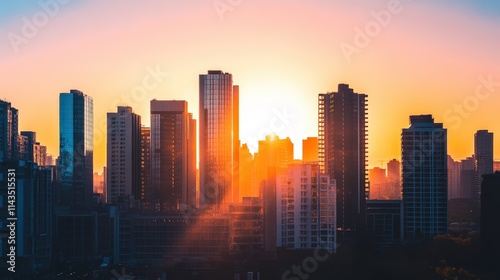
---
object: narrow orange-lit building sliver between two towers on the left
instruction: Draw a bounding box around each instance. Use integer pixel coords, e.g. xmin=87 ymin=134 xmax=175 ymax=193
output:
xmin=141 ymin=127 xmax=153 ymax=212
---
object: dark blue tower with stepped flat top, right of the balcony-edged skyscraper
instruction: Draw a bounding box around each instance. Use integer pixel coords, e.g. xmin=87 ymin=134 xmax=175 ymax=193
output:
xmin=401 ymin=115 xmax=448 ymax=241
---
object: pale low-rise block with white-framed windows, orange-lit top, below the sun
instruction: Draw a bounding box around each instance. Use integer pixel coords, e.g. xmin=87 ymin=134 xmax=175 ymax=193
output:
xmin=276 ymin=162 xmax=336 ymax=250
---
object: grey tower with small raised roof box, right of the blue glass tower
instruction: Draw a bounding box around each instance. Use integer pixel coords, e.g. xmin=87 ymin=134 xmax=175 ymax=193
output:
xmin=106 ymin=106 xmax=141 ymax=203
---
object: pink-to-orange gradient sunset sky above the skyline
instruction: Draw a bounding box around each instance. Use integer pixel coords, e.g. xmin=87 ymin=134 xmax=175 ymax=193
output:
xmin=0 ymin=0 xmax=500 ymax=171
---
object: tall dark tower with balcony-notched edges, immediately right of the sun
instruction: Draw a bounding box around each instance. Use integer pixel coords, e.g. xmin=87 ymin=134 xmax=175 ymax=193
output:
xmin=318 ymin=84 xmax=369 ymax=236
